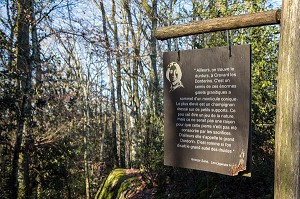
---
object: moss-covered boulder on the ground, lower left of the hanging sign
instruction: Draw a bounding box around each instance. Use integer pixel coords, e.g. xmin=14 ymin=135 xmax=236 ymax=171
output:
xmin=95 ymin=169 xmax=145 ymax=199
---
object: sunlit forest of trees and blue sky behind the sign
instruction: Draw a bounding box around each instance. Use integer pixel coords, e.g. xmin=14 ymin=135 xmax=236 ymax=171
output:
xmin=0 ymin=0 xmax=280 ymax=198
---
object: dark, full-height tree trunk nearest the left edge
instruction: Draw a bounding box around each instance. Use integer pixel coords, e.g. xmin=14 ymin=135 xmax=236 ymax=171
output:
xmin=12 ymin=0 xmax=31 ymax=198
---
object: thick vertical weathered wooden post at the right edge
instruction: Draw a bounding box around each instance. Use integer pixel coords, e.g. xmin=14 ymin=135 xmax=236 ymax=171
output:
xmin=274 ymin=0 xmax=300 ymax=199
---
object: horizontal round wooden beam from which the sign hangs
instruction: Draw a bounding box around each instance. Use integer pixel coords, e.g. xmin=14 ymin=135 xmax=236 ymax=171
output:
xmin=155 ymin=10 xmax=281 ymax=40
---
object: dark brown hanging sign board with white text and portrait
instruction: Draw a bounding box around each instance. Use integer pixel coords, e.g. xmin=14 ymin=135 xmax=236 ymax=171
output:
xmin=163 ymin=45 xmax=251 ymax=176
